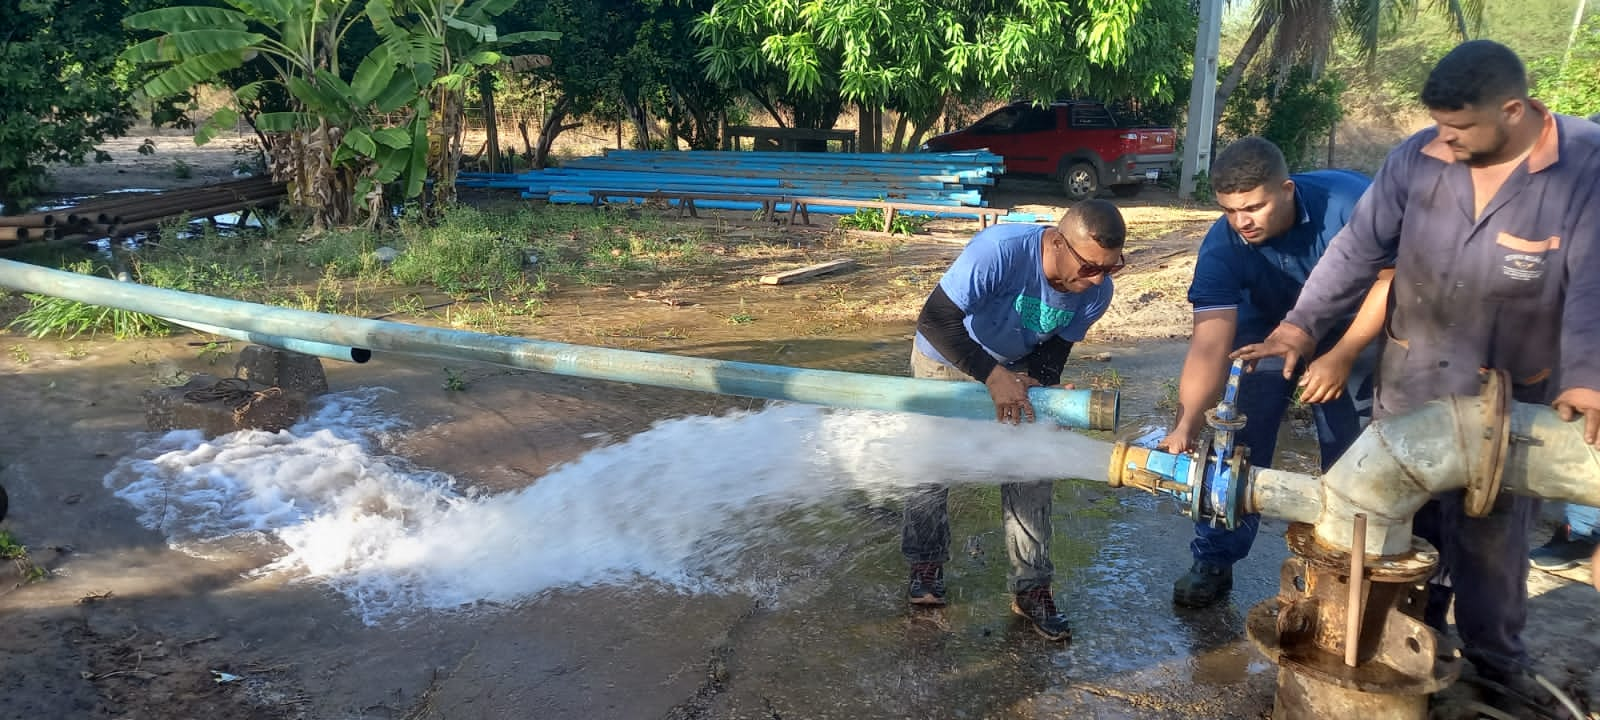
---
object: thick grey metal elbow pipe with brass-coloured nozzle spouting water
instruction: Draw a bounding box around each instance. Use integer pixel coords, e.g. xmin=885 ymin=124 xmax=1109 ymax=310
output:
xmin=1109 ymin=368 xmax=1600 ymax=557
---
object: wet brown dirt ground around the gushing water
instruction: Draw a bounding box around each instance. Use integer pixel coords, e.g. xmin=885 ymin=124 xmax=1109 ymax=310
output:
xmin=0 ymin=136 xmax=1600 ymax=720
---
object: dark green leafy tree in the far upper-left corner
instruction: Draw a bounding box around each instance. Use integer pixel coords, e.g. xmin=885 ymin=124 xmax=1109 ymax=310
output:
xmin=0 ymin=0 xmax=151 ymax=214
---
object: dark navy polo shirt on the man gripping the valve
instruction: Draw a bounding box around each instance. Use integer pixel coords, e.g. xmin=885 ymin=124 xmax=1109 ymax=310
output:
xmin=1189 ymin=170 xmax=1371 ymax=349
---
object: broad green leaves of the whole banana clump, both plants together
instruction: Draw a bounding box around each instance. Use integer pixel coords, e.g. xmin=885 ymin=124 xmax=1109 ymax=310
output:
xmin=123 ymin=0 xmax=549 ymax=226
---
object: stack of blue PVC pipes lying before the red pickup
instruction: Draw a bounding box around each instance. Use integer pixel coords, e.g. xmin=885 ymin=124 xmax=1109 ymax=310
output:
xmin=456 ymin=150 xmax=1034 ymax=221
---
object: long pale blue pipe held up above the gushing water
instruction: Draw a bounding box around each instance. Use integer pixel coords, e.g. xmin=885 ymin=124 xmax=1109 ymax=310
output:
xmin=0 ymin=261 xmax=1118 ymax=429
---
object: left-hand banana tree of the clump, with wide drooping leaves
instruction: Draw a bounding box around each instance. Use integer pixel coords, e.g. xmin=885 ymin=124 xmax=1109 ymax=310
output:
xmin=123 ymin=0 xmax=432 ymax=229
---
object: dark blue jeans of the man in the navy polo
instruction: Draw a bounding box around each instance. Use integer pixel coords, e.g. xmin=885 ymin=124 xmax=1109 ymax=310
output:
xmin=1189 ymin=347 xmax=1378 ymax=566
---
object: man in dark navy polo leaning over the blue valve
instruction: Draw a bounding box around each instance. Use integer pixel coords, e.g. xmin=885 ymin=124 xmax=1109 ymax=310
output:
xmin=1162 ymin=138 xmax=1389 ymax=608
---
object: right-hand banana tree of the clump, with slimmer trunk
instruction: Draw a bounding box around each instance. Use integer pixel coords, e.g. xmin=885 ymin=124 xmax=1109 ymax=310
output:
xmin=366 ymin=0 xmax=560 ymax=205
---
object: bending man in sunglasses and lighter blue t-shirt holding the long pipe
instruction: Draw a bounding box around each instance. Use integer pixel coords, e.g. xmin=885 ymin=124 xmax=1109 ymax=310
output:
xmin=901 ymin=200 xmax=1128 ymax=640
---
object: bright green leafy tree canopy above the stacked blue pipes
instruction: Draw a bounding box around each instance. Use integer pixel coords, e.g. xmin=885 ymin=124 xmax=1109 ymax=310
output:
xmin=696 ymin=0 xmax=1195 ymax=144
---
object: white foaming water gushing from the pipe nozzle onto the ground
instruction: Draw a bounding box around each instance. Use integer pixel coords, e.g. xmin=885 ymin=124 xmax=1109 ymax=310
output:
xmin=106 ymin=390 xmax=1109 ymax=622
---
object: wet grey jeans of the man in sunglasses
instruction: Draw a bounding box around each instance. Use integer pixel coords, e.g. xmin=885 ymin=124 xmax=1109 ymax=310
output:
xmin=901 ymin=349 xmax=1054 ymax=592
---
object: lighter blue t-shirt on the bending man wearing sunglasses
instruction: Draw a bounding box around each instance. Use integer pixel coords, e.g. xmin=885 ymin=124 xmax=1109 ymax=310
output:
xmin=917 ymin=224 xmax=1112 ymax=365
